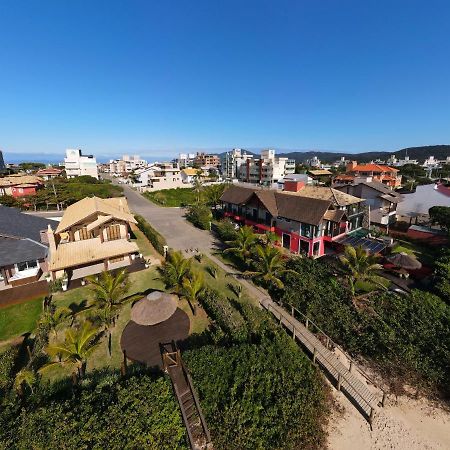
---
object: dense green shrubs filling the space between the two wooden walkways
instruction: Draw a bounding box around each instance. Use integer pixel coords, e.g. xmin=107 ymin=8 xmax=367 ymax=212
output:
xmin=183 ymin=290 xmax=327 ymax=450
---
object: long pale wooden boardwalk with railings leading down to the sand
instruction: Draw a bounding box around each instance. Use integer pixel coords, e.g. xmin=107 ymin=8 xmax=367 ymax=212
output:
xmin=260 ymin=297 xmax=384 ymax=423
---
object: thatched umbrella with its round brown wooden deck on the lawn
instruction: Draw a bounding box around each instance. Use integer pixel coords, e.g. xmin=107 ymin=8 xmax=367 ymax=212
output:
xmin=120 ymin=291 xmax=190 ymax=368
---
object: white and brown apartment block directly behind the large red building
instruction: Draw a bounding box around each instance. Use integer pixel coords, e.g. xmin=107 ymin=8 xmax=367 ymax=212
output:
xmin=239 ymin=149 xmax=295 ymax=186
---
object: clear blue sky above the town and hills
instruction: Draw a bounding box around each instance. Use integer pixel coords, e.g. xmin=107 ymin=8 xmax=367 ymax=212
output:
xmin=0 ymin=0 xmax=450 ymax=156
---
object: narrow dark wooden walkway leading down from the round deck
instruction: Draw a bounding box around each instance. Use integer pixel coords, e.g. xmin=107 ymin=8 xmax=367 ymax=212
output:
xmin=161 ymin=341 xmax=213 ymax=450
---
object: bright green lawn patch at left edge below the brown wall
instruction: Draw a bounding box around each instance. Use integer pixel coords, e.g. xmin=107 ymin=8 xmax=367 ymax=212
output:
xmin=0 ymin=297 xmax=43 ymax=341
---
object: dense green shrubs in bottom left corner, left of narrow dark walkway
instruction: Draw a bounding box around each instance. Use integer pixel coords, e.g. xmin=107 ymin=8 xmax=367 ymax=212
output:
xmin=0 ymin=371 xmax=188 ymax=450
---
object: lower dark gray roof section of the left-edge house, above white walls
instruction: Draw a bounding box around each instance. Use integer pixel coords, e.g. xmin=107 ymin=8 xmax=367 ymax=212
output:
xmin=0 ymin=237 xmax=48 ymax=267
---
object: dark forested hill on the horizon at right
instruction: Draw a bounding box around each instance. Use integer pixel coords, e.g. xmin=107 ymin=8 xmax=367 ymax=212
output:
xmin=277 ymin=145 xmax=450 ymax=163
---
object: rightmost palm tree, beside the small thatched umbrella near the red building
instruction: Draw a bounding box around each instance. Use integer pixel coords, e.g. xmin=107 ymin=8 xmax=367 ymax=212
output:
xmin=340 ymin=245 xmax=385 ymax=297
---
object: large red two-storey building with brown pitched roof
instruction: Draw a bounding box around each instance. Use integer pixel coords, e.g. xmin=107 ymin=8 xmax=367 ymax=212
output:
xmin=221 ymin=183 xmax=364 ymax=257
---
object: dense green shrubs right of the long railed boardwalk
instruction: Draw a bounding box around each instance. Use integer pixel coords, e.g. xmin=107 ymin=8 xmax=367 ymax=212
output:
xmin=277 ymin=258 xmax=450 ymax=390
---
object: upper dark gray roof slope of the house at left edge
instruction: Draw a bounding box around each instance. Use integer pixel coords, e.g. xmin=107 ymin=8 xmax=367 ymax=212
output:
xmin=0 ymin=207 xmax=58 ymax=242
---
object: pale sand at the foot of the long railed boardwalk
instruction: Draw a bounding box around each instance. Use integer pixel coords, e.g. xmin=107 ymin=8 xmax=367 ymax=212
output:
xmin=328 ymin=391 xmax=450 ymax=450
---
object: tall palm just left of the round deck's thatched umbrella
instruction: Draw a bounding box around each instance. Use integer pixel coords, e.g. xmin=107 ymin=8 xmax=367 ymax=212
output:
xmin=87 ymin=270 xmax=138 ymax=356
